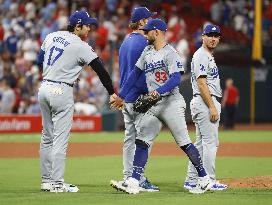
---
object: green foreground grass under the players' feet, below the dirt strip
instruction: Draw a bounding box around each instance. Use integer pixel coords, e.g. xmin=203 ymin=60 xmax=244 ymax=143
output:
xmin=0 ymin=157 xmax=272 ymax=205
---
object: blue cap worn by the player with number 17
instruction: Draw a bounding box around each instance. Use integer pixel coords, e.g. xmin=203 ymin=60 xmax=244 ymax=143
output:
xmin=69 ymin=11 xmax=98 ymax=26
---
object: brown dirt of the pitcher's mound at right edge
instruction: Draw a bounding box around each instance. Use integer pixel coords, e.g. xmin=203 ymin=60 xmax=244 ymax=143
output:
xmin=220 ymin=176 xmax=272 ymax=188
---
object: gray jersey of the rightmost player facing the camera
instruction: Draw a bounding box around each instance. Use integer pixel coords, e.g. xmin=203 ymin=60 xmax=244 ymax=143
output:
xmin=191 ymin=47 xmax=222 ymax=97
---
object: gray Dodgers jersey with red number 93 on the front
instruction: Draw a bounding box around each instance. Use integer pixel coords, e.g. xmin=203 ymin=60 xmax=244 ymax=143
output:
xmin=136 ymin=44 xmax=184 ymax=96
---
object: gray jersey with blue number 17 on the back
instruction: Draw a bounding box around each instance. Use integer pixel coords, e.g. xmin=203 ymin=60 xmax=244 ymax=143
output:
xmin=41 ymin=31 xmax=98 ymax=84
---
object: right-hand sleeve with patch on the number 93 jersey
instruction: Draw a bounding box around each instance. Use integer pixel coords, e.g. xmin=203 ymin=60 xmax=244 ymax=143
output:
xmin=166 ymin=49 xmax=184 ymax=75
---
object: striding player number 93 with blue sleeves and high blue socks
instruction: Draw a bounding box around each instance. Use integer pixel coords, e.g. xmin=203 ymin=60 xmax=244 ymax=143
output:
xmin=111 ymin=19 xmax=212 ymax=194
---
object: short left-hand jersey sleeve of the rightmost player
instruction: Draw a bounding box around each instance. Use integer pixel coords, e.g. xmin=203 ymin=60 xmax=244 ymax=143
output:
xmin=193 ymin=52 xmax=209 ymax=79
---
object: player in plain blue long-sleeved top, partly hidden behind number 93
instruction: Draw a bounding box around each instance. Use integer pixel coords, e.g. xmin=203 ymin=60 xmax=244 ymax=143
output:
xmin=110 ymin=7 xmax=159 ymax=192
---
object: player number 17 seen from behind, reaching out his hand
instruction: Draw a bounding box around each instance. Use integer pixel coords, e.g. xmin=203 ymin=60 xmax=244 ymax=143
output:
xmin=38 ymin=11 xmax=116 ymax=192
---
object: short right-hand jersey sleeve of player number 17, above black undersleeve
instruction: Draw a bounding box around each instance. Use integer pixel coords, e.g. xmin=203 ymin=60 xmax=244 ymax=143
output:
xmin=78 ymin=42 xmax=98 ymax=65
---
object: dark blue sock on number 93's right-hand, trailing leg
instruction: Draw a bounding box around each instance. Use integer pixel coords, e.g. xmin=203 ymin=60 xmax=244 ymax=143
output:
xmin=180 ymin=143 xmax=207 ymax=177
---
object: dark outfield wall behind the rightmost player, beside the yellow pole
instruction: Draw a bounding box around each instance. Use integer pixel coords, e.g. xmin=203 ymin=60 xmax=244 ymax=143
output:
xmin=180 ymin=65 xmax=272 ymax=123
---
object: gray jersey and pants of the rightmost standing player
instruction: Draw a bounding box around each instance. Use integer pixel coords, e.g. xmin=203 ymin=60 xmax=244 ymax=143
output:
xmin=186 ymin=47 xmax=222 ymax=183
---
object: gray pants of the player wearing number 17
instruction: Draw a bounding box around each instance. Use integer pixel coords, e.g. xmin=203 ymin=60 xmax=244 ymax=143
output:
xmin=38 ymin=82 xmax=74 ymax=183
